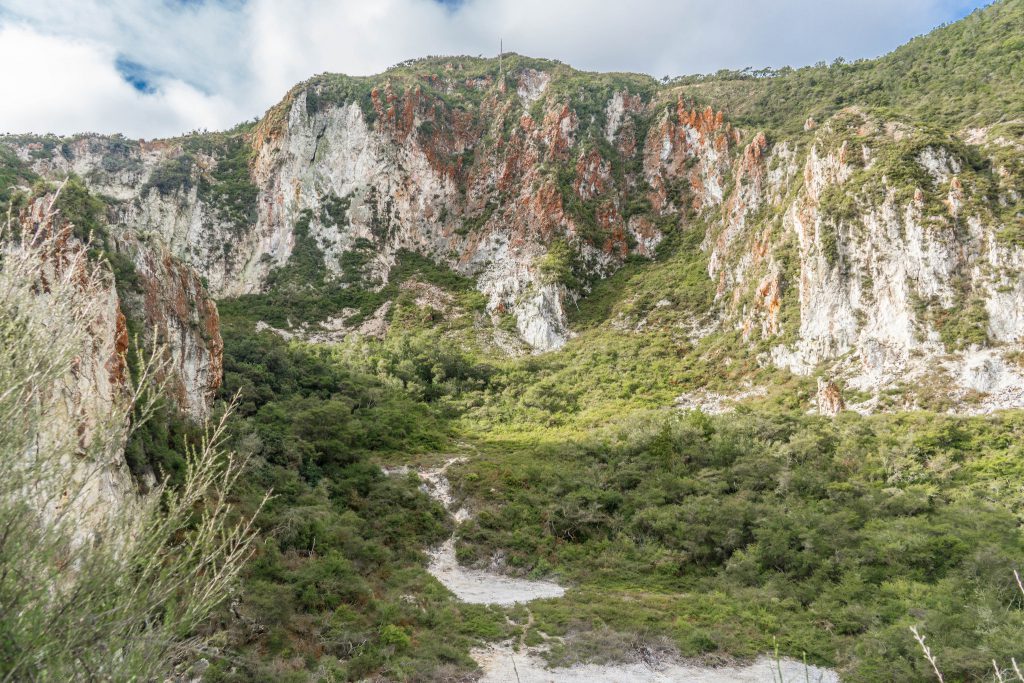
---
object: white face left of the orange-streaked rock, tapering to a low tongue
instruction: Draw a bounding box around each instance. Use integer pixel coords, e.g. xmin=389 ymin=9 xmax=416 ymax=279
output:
xmin=250 ymin=92 xmax=585 ymax=350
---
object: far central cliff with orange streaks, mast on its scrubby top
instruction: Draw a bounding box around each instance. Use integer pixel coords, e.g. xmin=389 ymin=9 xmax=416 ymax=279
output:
xmin=2 ymin=58 xmax=740 ymax=350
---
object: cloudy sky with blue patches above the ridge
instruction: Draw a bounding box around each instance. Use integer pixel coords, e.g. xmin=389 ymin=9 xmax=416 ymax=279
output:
xmin=0 ymin=0 xmax=989 ymax=138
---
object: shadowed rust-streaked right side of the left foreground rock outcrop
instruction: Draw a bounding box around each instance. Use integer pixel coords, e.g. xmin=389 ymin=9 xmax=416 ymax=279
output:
xmin=0 ymin=174 xmax=223 ymax=497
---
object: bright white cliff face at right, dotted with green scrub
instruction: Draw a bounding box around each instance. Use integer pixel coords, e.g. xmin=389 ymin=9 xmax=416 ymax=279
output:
xmin=705 ymin=111 xmax=1024 ymax=411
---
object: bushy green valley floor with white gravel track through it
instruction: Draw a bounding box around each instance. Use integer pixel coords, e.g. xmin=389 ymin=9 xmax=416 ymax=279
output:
xmin=209 ymin=305 xmax=1024 ymax=683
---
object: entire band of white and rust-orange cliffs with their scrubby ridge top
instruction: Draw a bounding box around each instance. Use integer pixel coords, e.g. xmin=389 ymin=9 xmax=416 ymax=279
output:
xmin=3 ymin=3 xmax=1024 ymax=413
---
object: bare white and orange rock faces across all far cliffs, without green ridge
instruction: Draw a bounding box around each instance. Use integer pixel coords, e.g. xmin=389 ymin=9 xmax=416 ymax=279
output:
xmin=9 ymin=84 xmax=1024 ymax=405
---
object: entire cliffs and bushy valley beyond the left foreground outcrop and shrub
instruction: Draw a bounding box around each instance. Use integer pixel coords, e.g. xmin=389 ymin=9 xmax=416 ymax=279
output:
xmin=0 ymin=0 xmax=1024 ymax=681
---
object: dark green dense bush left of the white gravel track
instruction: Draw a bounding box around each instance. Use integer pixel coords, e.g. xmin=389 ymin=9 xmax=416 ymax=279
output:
xmin=203 ymin=313 xmax=516 ymax=681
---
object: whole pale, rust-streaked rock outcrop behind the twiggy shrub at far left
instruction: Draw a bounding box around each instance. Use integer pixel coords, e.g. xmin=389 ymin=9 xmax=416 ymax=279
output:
xmin=0 ymin=188 xmax=221 ymax=542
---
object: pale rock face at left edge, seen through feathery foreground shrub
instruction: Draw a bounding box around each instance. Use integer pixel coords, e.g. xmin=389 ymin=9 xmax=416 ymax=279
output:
xmin=0 ymin=195 xmax=135 ymax=541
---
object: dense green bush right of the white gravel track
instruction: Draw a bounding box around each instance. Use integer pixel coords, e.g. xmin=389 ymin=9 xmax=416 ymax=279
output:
xmin=454 ymin=411 xmax=1024 ymax=681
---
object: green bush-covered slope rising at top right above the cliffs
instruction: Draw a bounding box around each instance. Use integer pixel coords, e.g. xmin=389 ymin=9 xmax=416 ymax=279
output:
xmin=675 ymin=0 xmax=1024 ymax=134
